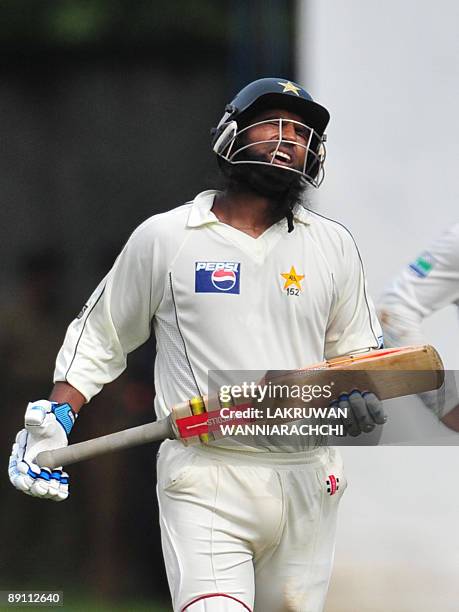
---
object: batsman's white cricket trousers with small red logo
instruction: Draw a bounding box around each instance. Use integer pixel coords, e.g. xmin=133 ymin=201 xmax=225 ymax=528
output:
xmin=157 ymin=440 xmax=346 ymax=612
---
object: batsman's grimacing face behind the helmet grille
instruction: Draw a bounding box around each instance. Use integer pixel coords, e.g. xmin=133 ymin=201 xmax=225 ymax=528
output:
xmin=237 ymin=108 xmax=311 ymax=172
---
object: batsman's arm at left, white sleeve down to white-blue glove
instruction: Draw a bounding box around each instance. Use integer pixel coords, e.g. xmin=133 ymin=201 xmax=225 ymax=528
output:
xmin=9 ymin=226 xmax=164 ymax=501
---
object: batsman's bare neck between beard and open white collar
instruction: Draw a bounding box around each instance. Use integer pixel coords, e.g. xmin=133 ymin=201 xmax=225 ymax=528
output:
xmin=212 ymin=191 xmax=277 ymax=238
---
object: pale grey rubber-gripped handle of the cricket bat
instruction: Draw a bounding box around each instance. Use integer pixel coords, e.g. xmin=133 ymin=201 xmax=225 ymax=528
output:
xmin=35 ymin=417 xmax=176 ymax=469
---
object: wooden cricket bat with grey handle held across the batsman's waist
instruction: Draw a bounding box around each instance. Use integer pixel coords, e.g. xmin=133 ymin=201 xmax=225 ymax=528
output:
xmin=36 ymin=345 xmax=444 ymax=469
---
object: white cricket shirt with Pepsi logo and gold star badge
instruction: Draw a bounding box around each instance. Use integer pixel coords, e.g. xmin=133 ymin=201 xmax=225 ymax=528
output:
xmin=54 ymin=191 xmax=381 ymax=426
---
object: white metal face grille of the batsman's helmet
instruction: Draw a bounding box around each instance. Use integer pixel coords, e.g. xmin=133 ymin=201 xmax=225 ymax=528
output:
xmin=214 ymin=118 xmax=326 ymax=188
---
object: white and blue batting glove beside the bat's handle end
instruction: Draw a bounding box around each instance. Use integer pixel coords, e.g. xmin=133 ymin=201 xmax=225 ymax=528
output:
xmin=8 ymin=400 xmax=76 ymax=501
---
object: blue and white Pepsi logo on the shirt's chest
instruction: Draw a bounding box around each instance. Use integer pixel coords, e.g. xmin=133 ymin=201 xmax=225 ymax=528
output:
xmin=194 ymin=261 xmax=241 ymax=294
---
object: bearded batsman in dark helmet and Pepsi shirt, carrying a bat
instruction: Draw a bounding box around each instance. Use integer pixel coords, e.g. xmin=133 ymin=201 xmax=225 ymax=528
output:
xmin=10 ymin=78 xmax=385 ymax=612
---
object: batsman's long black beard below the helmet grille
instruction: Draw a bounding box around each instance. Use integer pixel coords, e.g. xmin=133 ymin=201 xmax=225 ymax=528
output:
xmin=218 ymin=158 xmax=307 ymax=232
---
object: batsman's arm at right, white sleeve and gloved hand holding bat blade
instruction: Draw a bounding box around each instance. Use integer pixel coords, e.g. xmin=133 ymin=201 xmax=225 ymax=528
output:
xmin=325 ymin=226 xmax=387 ymax=436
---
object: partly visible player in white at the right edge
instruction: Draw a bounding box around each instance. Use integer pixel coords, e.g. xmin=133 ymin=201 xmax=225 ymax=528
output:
xmin=378 ymin=223 xmax=459 ymax=431
